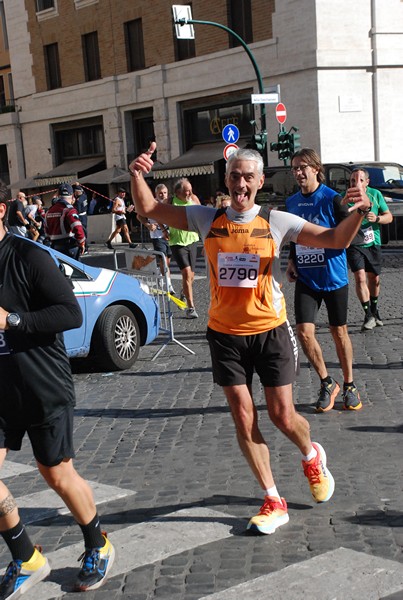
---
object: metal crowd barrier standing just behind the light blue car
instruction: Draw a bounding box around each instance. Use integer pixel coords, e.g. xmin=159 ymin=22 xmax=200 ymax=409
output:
xmin=113 ymin=248 xmax=195 ymax=360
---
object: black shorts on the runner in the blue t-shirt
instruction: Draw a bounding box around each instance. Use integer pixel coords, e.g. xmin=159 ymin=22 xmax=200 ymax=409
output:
xmin=294 ymin=280 xmax=348 ymax=327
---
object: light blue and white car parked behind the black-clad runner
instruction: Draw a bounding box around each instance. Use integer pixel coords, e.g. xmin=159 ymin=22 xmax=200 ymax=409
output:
xmin=47 ymin=242 xmax=160 ymax=371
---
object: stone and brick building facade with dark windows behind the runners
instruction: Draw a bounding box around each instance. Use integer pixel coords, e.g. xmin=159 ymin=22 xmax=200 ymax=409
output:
xmin=0 ymin=0 xmax=403 ymax=202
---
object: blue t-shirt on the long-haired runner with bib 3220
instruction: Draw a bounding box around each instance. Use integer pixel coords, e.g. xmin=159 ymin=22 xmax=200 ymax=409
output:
xmin=286 ymin=183 xmax=349 ymax=292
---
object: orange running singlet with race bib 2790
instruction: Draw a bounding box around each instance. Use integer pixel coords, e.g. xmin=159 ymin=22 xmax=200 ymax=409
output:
xmin=204 ymin=209 xmax=287 ymax=335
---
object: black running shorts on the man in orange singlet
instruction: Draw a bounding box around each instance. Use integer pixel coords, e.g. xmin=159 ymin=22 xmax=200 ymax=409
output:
xmin=206 ymin=321 xmax=299 ymax=387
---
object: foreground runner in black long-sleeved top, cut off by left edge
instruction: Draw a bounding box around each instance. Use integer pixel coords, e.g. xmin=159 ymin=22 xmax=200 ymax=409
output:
xmin=0 ymin=202 xmax=115 ymax=600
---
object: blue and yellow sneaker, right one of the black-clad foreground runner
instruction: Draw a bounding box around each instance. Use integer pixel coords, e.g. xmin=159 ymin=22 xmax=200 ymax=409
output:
xmin=74 ymin=531 xmax=115 ymax=592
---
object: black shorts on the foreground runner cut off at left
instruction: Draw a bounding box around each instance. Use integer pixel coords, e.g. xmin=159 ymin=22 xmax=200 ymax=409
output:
xmin=0 ymin=406 xmax=75 ymax=467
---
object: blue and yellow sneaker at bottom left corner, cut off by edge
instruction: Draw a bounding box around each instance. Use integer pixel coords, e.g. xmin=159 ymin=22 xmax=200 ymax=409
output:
xmin=0 ymin=546 xmax=50 ymax=600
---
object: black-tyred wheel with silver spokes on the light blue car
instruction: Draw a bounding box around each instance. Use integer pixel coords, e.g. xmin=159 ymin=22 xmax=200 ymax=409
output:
xmin=92 ymin=305 xmax=140 ymax=371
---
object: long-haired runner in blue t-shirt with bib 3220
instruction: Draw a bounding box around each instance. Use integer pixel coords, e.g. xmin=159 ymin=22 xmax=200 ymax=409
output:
xmin=286 ymin=148 xmax=362 ymax=413
